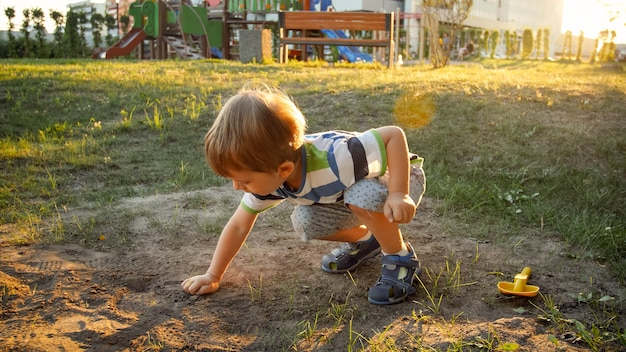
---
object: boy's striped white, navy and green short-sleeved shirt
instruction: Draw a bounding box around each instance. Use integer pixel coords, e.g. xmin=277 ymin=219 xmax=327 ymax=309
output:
xmin=241 ymin=130 xmax=387 ymax=214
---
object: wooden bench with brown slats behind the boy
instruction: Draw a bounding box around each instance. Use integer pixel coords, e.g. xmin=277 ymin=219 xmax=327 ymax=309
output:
xmin=278 ymin=11 xmax=395 ymax=67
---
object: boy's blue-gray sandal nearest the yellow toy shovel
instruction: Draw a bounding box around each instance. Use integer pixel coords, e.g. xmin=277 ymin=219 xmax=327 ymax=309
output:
xmin=367 ymin=243 xmax=421 ymax=304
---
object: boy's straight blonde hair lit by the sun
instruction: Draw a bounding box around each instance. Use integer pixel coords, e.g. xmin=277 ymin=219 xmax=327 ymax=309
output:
xmin=204 ymin=85 xmax=306 ymax=177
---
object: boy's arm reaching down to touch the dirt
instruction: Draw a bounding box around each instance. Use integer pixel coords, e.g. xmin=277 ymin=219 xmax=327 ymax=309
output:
xmin=181 ymin=205 xmax=257 ymax=295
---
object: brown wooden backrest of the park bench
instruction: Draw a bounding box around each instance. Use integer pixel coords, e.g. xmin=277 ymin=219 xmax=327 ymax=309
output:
xmin=278 ymin=11 xmax=393 ymax=31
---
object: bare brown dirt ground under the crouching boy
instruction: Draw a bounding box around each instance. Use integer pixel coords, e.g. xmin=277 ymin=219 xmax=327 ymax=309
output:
xmin=0 ymin=187 xmax=626 ymax=351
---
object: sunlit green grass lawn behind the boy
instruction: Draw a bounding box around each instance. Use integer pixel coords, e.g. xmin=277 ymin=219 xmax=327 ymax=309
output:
xmin=0 ymin=60 xmax=626 ymax=276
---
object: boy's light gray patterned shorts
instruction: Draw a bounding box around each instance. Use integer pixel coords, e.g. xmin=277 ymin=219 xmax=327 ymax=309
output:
xmin=291 ymin=165 xmax=426 ymax=241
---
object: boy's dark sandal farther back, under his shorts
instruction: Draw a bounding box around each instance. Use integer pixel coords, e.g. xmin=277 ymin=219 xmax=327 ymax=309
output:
xmin=322 ymin=236 xmax=380 ymax=274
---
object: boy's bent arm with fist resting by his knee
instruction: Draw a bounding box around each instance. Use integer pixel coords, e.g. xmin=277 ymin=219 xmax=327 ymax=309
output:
xmin=376 ymin=126 xmax=416 ymax=223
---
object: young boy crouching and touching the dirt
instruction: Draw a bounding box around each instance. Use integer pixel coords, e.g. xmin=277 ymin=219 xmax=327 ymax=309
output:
xmin=181 ymin=86 xmax=425 ymax=304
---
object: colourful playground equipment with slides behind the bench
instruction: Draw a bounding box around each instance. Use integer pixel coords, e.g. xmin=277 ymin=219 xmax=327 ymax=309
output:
xmin=99 ymin=0 xmax=393 ymax=62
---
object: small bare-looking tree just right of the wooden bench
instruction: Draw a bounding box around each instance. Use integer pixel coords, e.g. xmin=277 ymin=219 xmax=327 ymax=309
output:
xmin=421 ymin=0 xmax=474 ymax=68
